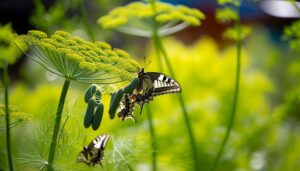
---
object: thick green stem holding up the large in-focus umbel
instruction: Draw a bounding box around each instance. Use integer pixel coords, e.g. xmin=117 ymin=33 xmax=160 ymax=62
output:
xmin=48 ymin=79 xmax=71 ymax=171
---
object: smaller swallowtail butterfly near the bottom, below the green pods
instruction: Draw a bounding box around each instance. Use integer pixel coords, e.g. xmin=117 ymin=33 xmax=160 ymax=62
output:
xmin=77 ymin=134 xmax=109 ymax=167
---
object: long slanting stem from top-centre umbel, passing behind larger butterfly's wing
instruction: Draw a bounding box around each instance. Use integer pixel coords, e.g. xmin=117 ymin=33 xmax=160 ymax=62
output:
xmin=150 ymin=0 xmax=200 ymax=171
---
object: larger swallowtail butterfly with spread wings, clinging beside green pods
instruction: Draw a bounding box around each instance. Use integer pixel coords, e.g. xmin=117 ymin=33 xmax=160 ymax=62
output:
xmin=118 ymin=69 xmax=181 ymax=121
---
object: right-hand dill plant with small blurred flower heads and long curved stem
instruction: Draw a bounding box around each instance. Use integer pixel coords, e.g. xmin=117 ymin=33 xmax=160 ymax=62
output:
xmin=210 ymin=0 xmax=251 ymax=171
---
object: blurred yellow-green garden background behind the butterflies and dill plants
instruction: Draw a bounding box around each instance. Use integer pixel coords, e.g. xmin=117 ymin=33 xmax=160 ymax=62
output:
xmin=0 ymin=0 xmax=300 ymax=171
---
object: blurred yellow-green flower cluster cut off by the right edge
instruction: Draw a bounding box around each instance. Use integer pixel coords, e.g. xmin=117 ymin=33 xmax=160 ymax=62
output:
xmin=284 ymin=20 xmax=300 ymax=51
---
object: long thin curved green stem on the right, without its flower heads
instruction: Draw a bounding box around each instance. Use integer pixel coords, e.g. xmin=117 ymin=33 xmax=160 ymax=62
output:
xmin=210 ymin=16 xmax=241 ymax=171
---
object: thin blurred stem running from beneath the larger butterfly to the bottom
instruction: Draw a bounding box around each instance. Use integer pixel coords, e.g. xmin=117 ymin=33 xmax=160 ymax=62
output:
xmin=146 ymin=106 xmax=157 ymax=171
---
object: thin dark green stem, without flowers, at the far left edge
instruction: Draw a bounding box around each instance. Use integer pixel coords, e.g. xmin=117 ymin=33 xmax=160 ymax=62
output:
xmin=3 ymin=63 xmax=14 ymax=171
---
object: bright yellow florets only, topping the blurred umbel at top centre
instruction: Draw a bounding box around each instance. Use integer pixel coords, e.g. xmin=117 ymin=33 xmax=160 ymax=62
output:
xmin=97 ymin=2 xmax=205 ymax=29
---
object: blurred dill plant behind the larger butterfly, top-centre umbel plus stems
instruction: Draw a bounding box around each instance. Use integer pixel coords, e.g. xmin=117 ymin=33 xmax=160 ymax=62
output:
xmin=97 ymin=0 xmax=205 ymax=170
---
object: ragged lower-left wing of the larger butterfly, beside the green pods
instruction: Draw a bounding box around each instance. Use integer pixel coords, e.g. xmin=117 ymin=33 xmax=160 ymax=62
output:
xmin=118 ymin=94 xmax=136 ymax=122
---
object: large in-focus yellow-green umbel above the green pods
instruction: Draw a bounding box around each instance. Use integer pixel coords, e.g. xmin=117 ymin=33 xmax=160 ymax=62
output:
xmin=18 ymin=30 xmax=140 ymax=83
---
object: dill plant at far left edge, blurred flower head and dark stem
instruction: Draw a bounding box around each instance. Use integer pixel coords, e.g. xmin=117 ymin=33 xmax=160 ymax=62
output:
xmin=0 ymin=24 xmax=21 ymax=170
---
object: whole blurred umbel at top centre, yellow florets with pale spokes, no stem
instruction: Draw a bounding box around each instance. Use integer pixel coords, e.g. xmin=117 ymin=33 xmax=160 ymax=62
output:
xmin=97 ymin=2 xmax=205 ymax=37
